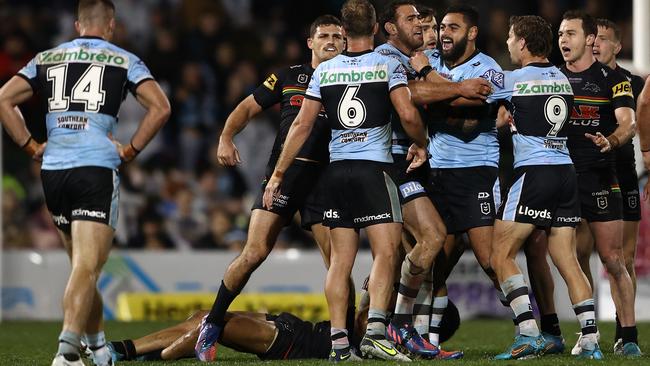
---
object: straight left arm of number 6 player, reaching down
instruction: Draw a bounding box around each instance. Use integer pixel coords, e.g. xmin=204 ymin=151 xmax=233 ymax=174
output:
xmin=262 ymin=98 xmax=322 ymax=209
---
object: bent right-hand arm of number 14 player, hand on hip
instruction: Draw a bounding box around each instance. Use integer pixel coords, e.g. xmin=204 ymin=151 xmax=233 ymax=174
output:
xmin=123 ymin=79 xmax=171 ymax=162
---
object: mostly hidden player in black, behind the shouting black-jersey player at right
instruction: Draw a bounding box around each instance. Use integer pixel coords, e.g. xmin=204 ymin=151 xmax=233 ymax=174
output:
xmin=578 ymin=19 xmax=644 ymax=353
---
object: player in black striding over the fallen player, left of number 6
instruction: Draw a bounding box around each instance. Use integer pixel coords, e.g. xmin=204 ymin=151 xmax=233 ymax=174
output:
xmin=196 ymin=15 xmax=344 ymax=361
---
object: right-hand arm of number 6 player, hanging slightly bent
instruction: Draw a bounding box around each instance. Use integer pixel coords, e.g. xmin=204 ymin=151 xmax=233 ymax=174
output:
xmin=390 ymin=87 xmax=427 ymax=172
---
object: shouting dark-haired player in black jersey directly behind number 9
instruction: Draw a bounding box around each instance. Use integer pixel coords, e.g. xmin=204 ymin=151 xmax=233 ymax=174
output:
xmin=558 ymin=11 xmax=641 ymax=356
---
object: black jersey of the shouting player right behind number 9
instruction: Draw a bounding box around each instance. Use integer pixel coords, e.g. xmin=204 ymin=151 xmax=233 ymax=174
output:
xmin=561 ymin=61 xmax=634 ymax=171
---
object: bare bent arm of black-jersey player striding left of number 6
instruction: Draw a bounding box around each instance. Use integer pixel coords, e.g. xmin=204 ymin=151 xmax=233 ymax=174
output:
xmin=217 ymin=94 xmax=263 ymax=166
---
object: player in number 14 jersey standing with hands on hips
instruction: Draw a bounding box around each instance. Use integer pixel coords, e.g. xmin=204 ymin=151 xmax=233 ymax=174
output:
xmin=0 ymin=0 xmax=170 ymax=366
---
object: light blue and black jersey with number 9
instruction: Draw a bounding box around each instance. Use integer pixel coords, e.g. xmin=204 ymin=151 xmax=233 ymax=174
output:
xmin=493 ymin=63 xmax=573 ymax=168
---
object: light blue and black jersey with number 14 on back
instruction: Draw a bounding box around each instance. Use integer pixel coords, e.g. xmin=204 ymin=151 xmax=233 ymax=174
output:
xmin=19 ymin=37 xmax=152 ymax=170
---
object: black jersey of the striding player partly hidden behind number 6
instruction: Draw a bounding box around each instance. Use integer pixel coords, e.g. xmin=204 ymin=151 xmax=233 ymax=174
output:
xmin=253 ymin=64 xmax=330 ymax=171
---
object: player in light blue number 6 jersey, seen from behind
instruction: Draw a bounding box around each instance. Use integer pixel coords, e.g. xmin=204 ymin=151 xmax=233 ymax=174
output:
xmin=264 ymin=0 xmax=426 ymax=361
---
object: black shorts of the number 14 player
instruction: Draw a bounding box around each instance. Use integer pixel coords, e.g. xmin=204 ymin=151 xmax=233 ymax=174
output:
xmin=41 ymin=166 xmax=120 ymax=234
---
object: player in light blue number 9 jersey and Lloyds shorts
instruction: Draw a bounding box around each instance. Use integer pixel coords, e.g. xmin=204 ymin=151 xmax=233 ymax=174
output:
xmin=490 ymin=16 xmax=602 ymax=360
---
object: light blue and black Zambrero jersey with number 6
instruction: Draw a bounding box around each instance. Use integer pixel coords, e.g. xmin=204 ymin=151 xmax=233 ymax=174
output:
xmin=305 ymin=50 xmax=407 ymax=163
